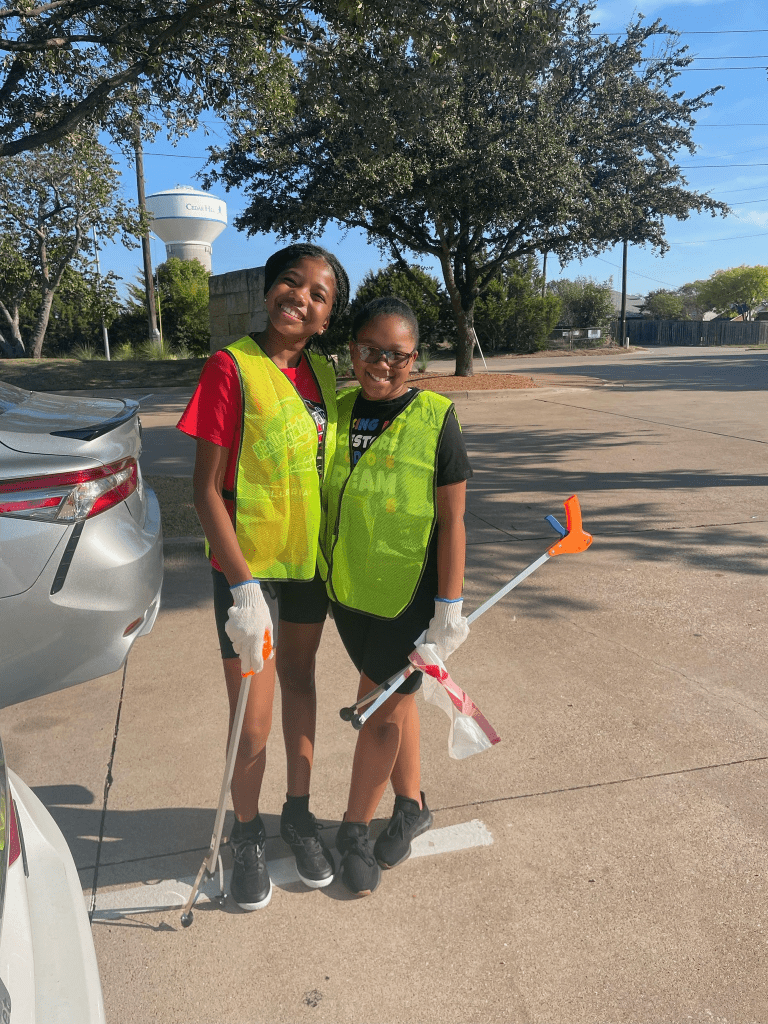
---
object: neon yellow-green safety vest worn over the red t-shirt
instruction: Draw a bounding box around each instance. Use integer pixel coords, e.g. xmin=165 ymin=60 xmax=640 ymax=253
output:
xmin=224 ymin=338 xmax=336 ymax=580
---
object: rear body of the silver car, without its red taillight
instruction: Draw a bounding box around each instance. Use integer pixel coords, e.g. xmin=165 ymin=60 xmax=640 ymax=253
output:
xmin=0 ymin=382 xmax=163 ymax=708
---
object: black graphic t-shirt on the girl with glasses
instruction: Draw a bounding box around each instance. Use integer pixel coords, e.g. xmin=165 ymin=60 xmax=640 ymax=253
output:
xmin=349 ymin=388 xmax=472 ymax=487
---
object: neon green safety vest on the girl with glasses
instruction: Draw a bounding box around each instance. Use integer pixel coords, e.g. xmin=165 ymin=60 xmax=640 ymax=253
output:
xmin=317 ymin=387 xmax=454 ymax=618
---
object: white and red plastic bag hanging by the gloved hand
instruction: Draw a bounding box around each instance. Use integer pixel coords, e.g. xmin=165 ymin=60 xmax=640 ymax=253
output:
xmin=409 ymin=643 xmax=501 ymax=761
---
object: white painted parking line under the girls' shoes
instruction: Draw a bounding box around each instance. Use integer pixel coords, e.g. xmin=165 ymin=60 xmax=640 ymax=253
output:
xmin=88 ymin=818 xmax=494 ymax=921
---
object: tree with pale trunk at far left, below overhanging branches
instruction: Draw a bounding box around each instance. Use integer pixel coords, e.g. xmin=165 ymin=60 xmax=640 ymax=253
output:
xmin=0 ymin=134 xmax=139 ymax=358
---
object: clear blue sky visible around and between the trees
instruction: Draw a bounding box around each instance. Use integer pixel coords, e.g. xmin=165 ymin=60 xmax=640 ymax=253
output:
xmin=94 ymin=0 xmax=768 ymax=295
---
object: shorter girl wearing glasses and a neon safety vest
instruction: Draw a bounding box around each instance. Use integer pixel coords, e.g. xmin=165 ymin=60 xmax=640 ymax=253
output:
xmin=318 ymin=297 xmax=472 ymax=896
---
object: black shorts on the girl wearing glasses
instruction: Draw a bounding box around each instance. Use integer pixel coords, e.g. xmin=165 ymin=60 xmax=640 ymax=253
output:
xmin=331 ymin=573 xmax=437 ymax=693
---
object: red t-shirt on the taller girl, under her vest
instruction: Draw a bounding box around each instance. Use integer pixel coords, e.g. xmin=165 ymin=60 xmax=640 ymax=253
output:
xmin=176 ymin=349 xmax=328 ymax=569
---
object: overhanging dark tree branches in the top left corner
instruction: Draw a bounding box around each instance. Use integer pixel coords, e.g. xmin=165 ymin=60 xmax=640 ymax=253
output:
xmin=0 ymin=0 xmax=306 ymax=157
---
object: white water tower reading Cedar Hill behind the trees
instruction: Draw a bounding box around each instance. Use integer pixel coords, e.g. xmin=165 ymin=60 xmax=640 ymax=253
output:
xmin=146 ymin=185 xmax=226 ymax=270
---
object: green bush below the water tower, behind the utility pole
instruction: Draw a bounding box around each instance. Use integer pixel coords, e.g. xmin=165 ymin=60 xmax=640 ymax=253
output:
xmin=111 ymin=256 xmax=211 ymax=358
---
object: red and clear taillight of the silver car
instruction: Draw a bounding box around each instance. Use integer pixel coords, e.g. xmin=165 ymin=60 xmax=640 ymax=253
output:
xmin=0 ymin=459 xmax=138 ymax=523
